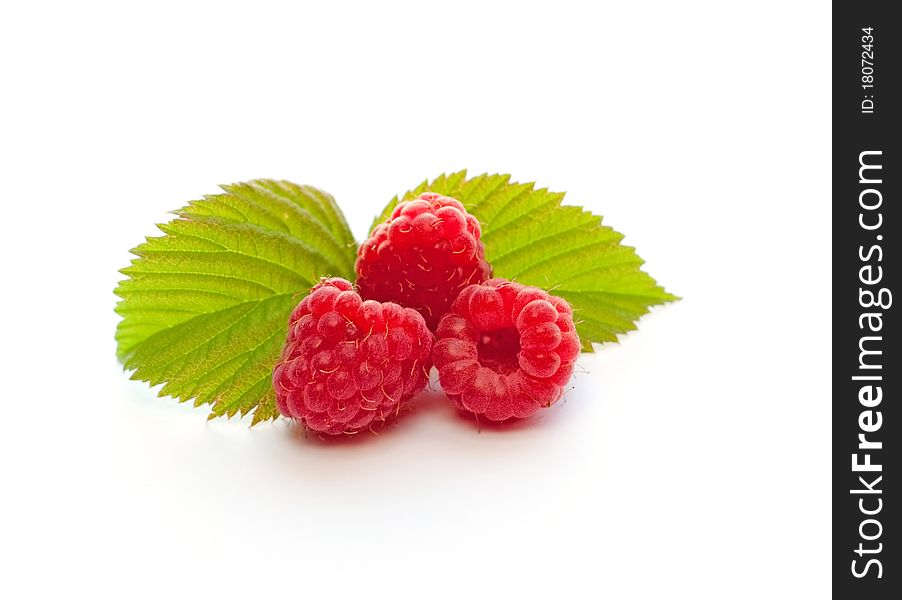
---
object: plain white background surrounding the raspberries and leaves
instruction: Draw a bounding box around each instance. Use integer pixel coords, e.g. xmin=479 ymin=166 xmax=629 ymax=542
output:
xmin=0 ymin=1 xmax=831 ymax=599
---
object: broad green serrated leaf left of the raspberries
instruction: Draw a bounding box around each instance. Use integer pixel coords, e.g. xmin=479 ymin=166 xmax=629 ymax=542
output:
xmin=116 ymin=180 xmax=357 ymax=423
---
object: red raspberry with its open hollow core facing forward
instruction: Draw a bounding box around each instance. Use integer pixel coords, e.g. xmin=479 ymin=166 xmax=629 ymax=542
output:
xmin=432 ymin=279 xmax=580 ymax=421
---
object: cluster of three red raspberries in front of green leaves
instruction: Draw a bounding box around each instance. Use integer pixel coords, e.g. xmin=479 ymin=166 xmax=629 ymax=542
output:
xmin=273 ymin=193 xmax=580 ymax=434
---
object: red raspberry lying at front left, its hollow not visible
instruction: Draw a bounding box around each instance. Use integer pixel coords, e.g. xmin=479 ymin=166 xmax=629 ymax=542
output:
xmin=273 ymin=278 xmax=432 ymax=434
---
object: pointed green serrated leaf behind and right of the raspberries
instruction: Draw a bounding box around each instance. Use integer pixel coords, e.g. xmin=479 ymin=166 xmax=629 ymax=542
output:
xmin=373 ymin=171 xmax=677 ymax=352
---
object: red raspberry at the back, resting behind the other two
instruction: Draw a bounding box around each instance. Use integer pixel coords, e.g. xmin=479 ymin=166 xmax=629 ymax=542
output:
xmin=356 ymin=193 xmax=492 ymax=331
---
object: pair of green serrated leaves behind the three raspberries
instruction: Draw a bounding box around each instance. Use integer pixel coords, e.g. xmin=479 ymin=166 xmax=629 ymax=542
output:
xmin=116 ymin=171 xmax=676 ymax=423
